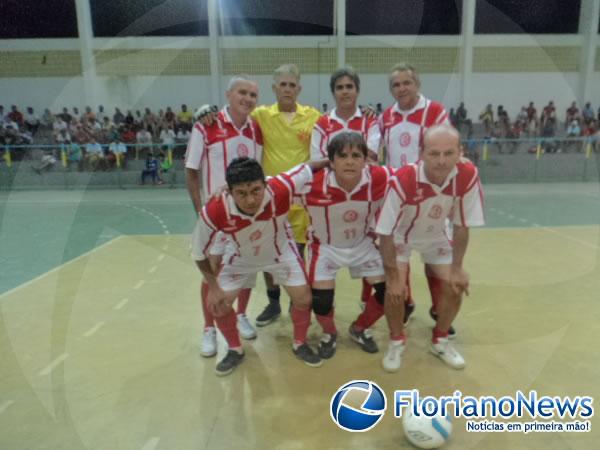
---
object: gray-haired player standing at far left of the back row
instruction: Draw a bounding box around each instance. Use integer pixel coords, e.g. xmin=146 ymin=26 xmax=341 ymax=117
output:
xmin=185 ymin=75 xmax=262 ymax=357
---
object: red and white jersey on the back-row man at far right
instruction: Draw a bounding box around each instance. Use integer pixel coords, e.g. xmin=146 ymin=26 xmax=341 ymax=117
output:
xmin=379 ymin=95 xmax=450 ymax=167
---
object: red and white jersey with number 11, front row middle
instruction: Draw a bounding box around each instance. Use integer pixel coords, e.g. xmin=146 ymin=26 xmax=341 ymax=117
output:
xmin=299 ymin=165 xmax=391 ymax=248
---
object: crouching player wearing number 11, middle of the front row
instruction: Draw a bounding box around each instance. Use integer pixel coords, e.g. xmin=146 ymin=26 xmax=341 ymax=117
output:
xmin=300 ymin=131 xmax=389 ymax=359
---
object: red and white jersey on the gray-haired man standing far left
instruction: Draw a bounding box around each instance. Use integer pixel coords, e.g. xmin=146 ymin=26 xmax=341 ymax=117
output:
xmin=185 ymin=107 xmax=263 ymax=201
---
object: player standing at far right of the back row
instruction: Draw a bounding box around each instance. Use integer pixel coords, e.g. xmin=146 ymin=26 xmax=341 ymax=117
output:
xmin=379 ymin=63 xmax=456 ymax=337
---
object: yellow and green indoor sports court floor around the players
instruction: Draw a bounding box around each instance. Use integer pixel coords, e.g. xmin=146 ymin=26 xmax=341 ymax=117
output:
xmin=0 ymin=183 xmax=600 ymax=450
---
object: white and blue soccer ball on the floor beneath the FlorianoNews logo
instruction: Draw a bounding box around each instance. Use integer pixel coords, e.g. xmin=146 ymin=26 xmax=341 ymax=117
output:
xmin=402 ymin=408 xmax=452 ymax=448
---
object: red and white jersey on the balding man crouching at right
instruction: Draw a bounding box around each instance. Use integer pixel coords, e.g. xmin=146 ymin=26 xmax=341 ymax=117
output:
xmin=376 ymin=162 xmax=484 ymax=244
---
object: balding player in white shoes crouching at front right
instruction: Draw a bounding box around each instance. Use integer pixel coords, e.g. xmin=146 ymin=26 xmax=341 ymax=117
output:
xmin=376 ymin=125 xmax=484 ymax=372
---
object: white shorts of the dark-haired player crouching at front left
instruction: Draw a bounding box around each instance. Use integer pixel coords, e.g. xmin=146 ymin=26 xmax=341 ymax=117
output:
xmin=218 ymin=242 xmax=308 ymax=291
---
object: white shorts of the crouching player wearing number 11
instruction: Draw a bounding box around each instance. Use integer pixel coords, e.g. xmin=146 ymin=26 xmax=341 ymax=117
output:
xmin=308 ymin=238 xmax=384 ymax=284
